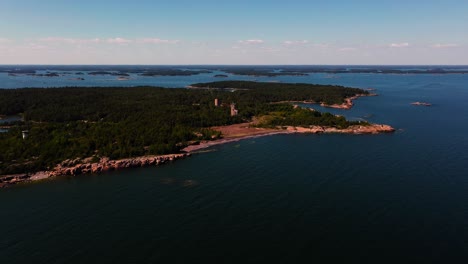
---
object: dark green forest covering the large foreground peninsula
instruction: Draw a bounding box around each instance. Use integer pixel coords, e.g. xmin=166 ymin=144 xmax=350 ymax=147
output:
xmin=0 ymin=82 xmax=366 ymax=175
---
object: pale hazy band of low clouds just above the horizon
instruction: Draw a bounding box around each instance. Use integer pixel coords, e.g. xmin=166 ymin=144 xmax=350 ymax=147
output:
xmin=0 ymin=36 xmax=468 ymax=64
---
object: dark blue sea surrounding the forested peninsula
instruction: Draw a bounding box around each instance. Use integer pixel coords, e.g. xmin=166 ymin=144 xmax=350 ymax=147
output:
xmin=0 ymin=66 xmax=468 ymax=264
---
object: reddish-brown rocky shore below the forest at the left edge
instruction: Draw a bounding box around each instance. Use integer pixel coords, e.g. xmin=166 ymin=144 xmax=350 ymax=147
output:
xmin=0 ymin=153 xmax=190 ymax=188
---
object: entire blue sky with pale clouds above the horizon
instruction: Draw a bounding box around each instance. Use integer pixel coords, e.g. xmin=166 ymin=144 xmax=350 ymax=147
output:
xmin=0 ymin=0 xmax=468 ymax=65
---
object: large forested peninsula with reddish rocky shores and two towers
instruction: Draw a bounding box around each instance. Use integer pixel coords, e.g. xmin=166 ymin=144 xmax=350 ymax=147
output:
xmin=0 ymin=81 xmax=394 ymax=187
